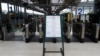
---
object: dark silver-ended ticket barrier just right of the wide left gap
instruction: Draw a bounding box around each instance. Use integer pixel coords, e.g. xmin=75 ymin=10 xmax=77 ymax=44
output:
xmin=24 ymin=22 xmax=36 ymax=43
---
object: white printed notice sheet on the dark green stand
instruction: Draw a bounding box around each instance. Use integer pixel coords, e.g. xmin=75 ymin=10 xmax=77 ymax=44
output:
xmin=46 ymin=16 xmax=61 ymax=38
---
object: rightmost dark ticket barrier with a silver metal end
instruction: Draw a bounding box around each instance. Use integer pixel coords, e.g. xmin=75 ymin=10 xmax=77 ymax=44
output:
xmin=85 ymin=23 xmax=99 ymax=43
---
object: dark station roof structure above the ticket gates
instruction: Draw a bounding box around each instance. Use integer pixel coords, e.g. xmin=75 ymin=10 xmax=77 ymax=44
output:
xmin=1 ymin=0 xmax=81 ymax=13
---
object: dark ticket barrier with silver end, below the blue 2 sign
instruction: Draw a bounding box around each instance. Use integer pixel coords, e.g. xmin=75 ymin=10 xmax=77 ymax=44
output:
xmin=73 ymin=23 xmax=85 ymax=43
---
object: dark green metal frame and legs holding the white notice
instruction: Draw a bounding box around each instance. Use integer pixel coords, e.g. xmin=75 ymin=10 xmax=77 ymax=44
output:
xmin=43 ymin=15 xmax=64 ymax=56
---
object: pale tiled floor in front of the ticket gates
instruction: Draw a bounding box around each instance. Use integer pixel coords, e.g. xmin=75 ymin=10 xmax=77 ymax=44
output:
xmin=0 ymin=41 xmax=100 ymax=56
